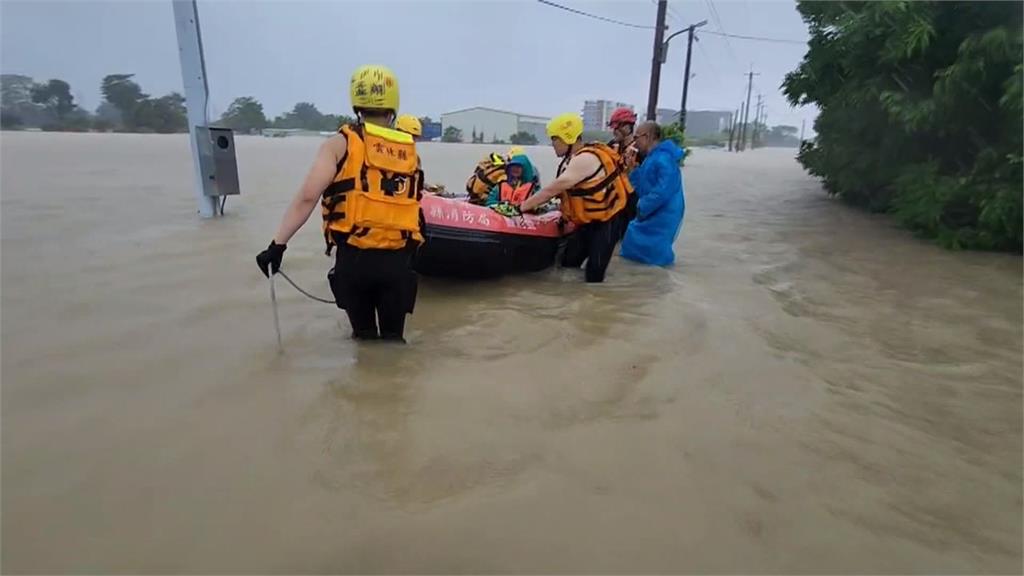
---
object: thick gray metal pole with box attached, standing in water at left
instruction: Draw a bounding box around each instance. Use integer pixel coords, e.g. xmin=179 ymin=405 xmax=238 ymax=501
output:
xmin=171 ymin=0 xmax=218 ymax=218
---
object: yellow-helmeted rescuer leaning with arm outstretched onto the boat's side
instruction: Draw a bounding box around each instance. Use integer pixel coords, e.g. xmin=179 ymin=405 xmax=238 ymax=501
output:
xmin=520 ymin=113 xmax=633 ymax=282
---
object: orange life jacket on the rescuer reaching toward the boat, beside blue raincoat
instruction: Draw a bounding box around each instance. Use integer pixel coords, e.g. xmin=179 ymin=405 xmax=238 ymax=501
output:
xmin=558 ymin=142 xmax=633 ymax=224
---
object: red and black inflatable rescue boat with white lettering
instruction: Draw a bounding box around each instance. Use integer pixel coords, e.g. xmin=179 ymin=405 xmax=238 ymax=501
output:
xmin=416 ymin=193 xmax=571 ymax=278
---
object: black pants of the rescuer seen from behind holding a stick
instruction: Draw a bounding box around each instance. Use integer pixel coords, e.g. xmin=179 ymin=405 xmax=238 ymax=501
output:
xmin=328 ymin=244 xmax=417 ymax=341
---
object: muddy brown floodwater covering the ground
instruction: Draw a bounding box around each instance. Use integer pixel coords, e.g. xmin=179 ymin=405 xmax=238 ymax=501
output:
xmin=0 ymin=132 xmax=1022 ymax=573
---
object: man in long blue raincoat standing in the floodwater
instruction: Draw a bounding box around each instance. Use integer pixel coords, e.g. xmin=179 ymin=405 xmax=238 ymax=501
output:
xmin=622 ymin=122 xmax=686 ymax=266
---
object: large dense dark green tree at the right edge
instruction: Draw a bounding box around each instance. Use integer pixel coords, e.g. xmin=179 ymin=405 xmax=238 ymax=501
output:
xmin=782 ymin=0 xmax=1024 ymax=251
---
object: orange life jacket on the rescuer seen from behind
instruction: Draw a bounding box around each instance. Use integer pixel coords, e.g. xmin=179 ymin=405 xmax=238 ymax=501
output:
xmin=321 ymin=124 xmax=423 ymax=253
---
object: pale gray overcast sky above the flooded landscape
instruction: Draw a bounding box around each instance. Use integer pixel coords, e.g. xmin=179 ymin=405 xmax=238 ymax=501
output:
xmin=0 ymin=0 xmax=815 ymax=130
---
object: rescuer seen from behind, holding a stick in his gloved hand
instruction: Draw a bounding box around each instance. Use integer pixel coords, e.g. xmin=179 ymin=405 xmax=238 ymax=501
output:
xmin=256 ymin=66 xmax=423 ymax=341
